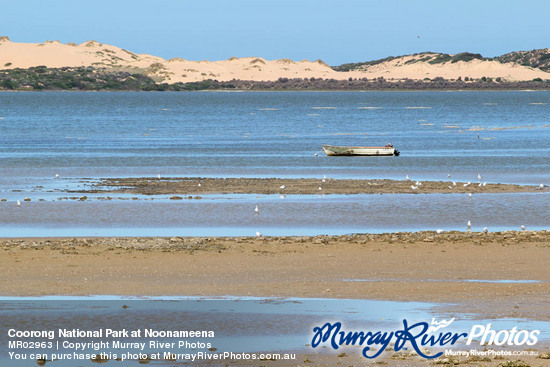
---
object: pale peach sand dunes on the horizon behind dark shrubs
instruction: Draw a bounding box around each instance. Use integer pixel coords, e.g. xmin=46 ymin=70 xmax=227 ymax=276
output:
xmin=0 ymin=37 xmax=550 ymax=83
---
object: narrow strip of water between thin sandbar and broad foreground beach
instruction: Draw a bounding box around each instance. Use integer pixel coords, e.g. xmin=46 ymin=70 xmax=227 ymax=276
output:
xmin=0 ymin=193 xmax=550 ymax=237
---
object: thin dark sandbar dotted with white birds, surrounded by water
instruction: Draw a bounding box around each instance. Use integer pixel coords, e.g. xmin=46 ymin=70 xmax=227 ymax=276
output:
xmin=90 ymin=177 xmax=546 ymax=195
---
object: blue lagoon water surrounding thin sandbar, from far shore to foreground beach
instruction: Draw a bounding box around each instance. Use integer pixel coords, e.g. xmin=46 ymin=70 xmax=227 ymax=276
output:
xmin=0 ymin=92 xmax=550 ymax=236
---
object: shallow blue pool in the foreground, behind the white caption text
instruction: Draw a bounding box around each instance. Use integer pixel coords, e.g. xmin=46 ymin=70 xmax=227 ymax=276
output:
xmin=0 ymin=296 xmax=550 ymax=366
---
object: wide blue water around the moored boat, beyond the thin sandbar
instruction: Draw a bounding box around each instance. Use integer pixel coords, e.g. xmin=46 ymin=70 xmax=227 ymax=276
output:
xmin=0 ymin=91 xmax=550 ymax=186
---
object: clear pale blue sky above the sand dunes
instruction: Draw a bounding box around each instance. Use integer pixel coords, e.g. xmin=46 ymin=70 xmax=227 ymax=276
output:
xmin=0 ymin=0 xmax=550 ymax=65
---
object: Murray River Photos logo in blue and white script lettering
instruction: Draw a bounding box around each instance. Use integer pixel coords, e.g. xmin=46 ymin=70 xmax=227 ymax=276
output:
xmin=311 ymin=318 xmax=540 ymax=359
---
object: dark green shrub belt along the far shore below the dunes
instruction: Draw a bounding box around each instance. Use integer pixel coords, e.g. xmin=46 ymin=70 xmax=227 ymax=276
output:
xmin=0 ymin=66 xmax=550 ymax=91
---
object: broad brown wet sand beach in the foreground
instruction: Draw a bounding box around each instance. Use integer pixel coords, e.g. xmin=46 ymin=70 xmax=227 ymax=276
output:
xmin=0 ymin=231 xmax=550 ymax=320
